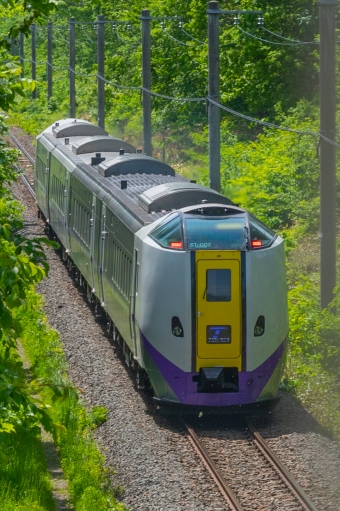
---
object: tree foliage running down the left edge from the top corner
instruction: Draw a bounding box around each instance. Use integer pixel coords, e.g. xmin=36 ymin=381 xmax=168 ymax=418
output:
xmin=0 ymin=0 xmax=62 ymax=433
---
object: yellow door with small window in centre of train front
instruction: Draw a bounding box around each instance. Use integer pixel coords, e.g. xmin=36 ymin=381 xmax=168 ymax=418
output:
xmin=196 ymin=250 xmax=242 ymax=371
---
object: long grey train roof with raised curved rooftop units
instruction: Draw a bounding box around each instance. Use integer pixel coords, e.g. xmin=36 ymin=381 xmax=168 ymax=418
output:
xmin=37 ymin=120 xmax=235 ymax=225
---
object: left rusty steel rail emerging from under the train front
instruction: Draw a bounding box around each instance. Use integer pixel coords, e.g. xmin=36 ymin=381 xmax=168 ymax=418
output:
xmin=182 ymin=418 xmax=244 ymax=511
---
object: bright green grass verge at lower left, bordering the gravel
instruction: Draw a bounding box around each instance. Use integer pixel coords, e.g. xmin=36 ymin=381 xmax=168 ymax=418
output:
xmin=13 ymin=292 xmax=126 ymax=511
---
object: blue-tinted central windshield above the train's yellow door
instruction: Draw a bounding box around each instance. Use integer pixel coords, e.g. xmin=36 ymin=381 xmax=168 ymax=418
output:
xmin=185 ymin=215 xmax=247 ymax=250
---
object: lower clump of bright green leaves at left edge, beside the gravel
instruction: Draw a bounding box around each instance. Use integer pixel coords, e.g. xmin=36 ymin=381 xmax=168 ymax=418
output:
xmin=0 ymin=200 xmax=69 ymax=433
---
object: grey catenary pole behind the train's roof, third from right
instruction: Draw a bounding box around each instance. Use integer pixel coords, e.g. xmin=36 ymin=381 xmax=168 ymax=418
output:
xmin=141 ymin=9 xmax=152 ymax=156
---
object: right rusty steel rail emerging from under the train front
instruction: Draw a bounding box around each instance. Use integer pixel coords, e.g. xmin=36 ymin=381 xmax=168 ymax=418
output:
xmin=245 ymin=418 xmax=318 ymax=511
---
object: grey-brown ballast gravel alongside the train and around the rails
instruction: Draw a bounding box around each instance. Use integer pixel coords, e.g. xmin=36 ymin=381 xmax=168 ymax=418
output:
xmin=9 ymin=130 xmax=340 ymax=511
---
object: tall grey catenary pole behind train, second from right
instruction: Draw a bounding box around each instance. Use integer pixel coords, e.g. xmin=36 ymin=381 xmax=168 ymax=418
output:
xmin=207 ymin=1 xmax=221 ymax=192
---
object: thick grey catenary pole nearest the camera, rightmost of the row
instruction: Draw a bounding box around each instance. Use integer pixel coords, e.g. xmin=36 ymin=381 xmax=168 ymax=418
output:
xmin=318 ymin=0 xmax=339 ymax=308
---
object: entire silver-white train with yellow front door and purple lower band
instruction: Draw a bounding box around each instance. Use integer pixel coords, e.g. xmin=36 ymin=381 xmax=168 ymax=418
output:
xmin=35 ymin=119 xmax=288 ymax=409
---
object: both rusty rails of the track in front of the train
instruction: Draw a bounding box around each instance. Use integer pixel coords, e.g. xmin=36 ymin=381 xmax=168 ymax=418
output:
xmin=183 ymin=418 xmax=318 ymax=511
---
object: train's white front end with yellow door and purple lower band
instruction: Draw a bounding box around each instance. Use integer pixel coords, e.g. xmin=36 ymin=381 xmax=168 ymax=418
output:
xmin=133 ymin=204 xmax=288 ymax=408
